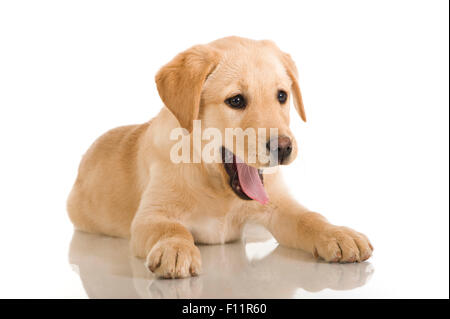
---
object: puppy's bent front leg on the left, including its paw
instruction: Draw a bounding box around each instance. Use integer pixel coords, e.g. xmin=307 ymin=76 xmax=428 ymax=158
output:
xmin=131 ymin=209 xmax=201 ymax=278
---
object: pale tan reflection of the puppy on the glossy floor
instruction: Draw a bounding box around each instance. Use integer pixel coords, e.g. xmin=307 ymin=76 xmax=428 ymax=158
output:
xmin=69 ymin=231 xmax=373 ymax=298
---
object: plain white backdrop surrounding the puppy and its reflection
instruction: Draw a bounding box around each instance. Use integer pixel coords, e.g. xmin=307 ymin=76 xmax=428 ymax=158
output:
xmin=0 ymin=0 xmax=449 ymax=298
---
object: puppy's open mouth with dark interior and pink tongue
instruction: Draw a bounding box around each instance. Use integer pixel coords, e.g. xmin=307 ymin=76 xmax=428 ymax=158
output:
xmin=222 ymin=146 xmax=269 ymax=205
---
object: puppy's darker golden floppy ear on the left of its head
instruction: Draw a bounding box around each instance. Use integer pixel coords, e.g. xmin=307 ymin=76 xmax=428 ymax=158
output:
xmin=155 ymin=45 xmax=219 ymax=132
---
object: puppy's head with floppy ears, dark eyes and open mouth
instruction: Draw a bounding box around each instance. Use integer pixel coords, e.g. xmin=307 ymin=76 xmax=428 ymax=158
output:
xmin=156 ymin=37 xmax=306 ymax=202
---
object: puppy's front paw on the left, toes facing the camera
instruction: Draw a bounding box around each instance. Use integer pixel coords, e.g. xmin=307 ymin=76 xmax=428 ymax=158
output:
xmin=145 ymin=238 xmax=202 ymax=278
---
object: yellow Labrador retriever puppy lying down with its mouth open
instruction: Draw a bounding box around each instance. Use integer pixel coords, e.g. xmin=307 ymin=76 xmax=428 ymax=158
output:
xmin=67 ymin=37 xmax=373 ymax=278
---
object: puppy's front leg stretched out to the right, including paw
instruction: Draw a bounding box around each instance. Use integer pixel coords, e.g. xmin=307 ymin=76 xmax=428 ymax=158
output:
xmin=266 ymin=195 xmax=373 ymax=262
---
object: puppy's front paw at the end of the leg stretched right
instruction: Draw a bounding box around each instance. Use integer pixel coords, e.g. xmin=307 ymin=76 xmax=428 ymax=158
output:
xmin=313 ymin=225 xmax=373 ymax=263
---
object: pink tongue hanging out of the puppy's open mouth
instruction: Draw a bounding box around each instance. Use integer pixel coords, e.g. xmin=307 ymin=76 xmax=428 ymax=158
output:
xmin=236 ymin=157 xmax=269 ymax=205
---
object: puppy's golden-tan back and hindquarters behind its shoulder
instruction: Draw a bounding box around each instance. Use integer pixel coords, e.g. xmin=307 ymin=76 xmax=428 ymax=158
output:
xmin=67 ymin=122 xmax=150 ymax=237
